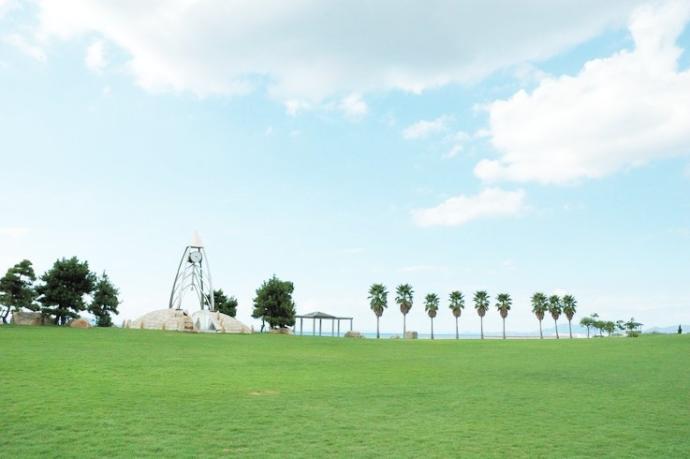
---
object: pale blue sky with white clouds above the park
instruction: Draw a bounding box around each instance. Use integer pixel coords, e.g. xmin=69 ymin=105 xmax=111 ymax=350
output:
xmin=0 ymin=0 xmax=690 ymax=333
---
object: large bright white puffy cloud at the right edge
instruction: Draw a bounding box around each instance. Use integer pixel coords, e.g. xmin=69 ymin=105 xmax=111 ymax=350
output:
xmin=475 ymin=2 xmax=690 ymax=183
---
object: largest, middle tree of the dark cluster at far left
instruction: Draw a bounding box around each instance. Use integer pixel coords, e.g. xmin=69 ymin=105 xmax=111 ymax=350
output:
xmin=36 ymin=257 xmax=96 ymax=325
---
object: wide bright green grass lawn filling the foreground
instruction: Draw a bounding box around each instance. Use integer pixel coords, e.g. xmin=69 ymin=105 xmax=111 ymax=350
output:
xmin=0 ymin=326 xmax=690 ymax=457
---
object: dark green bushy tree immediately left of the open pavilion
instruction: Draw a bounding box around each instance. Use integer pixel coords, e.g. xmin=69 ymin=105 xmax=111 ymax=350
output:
xmin=252 ymin=274 xmax=295 ymax=329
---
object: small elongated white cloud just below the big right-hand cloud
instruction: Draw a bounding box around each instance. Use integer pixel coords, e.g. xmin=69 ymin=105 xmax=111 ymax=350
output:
xmin=412 ymin=188 xmax=525 ymax=226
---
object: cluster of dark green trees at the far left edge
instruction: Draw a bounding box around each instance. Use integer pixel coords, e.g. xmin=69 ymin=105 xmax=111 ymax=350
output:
xmin=0 ymin=257 xmax=120 ymax=327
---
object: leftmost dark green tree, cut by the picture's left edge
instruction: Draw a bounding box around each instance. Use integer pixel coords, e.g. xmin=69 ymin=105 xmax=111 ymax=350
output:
xmin=0 ymin=260 xmax=38 ymax=324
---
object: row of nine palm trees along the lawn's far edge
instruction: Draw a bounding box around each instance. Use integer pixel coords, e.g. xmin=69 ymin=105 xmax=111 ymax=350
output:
xmin=369 ymin=284 xmax=577 ymax=339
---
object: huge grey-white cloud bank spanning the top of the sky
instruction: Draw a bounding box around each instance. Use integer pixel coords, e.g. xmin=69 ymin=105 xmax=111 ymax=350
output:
xmin=30 ymin=0 xmax=639 ymax=105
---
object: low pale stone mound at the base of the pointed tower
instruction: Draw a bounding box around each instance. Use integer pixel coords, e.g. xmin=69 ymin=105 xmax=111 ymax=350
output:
xmin=126 ymin=309 xmax=252 ymax=333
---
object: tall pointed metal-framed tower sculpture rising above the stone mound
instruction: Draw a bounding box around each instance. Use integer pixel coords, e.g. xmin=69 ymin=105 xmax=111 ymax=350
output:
xmin=168 ymin=232 xmax=216 ymax=311
